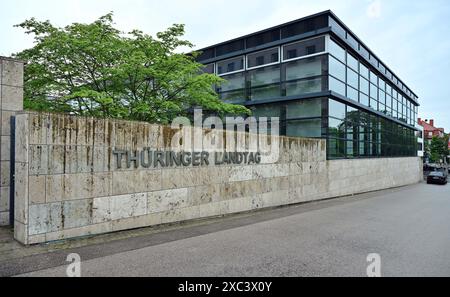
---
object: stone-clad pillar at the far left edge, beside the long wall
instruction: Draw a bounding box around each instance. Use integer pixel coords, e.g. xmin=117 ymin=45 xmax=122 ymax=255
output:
xmin=0 ymin=57 xmax=24 ymax=226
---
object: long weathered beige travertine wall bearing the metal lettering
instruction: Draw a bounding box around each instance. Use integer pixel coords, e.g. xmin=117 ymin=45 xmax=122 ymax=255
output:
xmin=15 ymin=114 xmax=421 ymax=244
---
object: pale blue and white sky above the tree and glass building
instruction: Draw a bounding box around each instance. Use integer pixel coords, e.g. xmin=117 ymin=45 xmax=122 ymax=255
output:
xmin=0 ymin=0 xmax=450 ymax=132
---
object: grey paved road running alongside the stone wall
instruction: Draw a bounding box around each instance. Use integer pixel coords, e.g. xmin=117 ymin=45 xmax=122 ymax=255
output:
xmin=13 ymin=184 xmax=450 ymax=277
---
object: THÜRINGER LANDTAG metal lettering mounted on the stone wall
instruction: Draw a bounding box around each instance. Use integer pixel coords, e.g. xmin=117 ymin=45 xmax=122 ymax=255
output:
xmin=113 ymin=149 xmax=261 ymax=169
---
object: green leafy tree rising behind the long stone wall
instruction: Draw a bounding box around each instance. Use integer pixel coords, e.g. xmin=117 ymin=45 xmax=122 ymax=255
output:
xmin=16 ymin=13 xmax=250 ymax=124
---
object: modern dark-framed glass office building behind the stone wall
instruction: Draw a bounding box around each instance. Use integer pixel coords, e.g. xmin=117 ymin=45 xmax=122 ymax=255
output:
xmin=198 ymin=11 xmax=419 ymax=159
